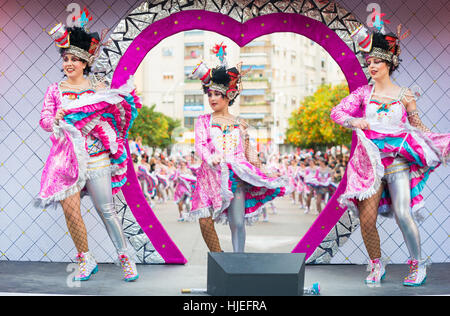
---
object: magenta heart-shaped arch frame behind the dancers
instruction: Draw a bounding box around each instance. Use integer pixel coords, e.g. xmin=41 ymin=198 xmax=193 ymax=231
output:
xmin=112 ymin=10 xmax=367 ymax=264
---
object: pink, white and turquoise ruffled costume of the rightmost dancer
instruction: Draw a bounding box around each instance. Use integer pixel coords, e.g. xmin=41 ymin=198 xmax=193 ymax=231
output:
xmin=331 ymin=85 xmax=450 ymax=214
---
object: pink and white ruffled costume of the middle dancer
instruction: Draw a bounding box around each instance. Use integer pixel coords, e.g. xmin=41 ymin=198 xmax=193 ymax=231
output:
xmin=190 ymin=114 xmax=291 ymax=224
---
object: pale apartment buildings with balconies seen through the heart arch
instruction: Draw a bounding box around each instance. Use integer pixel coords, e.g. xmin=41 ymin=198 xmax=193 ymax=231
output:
xmin=135 ymin=30 xmax=345 ymax=153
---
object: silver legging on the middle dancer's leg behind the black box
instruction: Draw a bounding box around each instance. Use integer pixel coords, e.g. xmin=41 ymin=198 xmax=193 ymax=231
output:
xmin=228 ymin=181 xmax=245 ymax=252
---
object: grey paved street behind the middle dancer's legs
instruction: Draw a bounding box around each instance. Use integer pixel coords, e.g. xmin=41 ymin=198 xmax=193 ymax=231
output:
xmin=153 ymin=197 xmax=317 ymax=265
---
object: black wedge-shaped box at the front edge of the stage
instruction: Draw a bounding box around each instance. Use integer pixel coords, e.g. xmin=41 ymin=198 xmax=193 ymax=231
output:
xmin=207 ymin=252 xmax=305 ymax=296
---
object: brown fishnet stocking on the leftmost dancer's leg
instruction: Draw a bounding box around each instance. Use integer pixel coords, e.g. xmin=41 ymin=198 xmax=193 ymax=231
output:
xmin=61 ymin=192 xmax=89 ymax=253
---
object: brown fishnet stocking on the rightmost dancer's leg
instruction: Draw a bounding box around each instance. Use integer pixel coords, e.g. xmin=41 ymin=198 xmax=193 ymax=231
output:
xmin=358 ymin=184 xmax=383 ymax=260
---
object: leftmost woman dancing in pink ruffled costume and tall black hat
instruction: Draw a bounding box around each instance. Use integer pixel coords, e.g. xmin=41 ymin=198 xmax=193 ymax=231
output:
xmin=39 ymin=24 xmax=141 ymax=281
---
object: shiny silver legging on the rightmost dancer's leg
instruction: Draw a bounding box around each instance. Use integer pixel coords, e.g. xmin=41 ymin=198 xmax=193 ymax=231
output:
xmin=387 ymin=172 xmax=421 ymax=260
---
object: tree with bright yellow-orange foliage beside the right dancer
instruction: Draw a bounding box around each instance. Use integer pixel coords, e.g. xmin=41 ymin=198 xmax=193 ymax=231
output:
xmin=286 ymin=84 xmax=352 ymax=149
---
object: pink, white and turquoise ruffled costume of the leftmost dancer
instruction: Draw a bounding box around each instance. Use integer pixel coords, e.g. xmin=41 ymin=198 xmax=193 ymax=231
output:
xmin=39 ymin=77 xmax=142 ymax=205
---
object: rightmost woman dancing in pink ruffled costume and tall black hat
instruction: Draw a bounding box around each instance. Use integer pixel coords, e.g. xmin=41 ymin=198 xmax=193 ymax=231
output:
xmin=331 ymin=25 xmax=450 ymax=286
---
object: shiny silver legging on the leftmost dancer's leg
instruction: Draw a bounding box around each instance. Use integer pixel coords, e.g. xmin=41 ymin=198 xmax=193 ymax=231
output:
xmin=86 ymin=174 xmax=127 ymax=254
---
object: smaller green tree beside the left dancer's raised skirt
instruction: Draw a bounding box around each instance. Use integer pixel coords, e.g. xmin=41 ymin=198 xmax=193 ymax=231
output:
xmin=130 ymin=104 xmax=181 ymax=149
